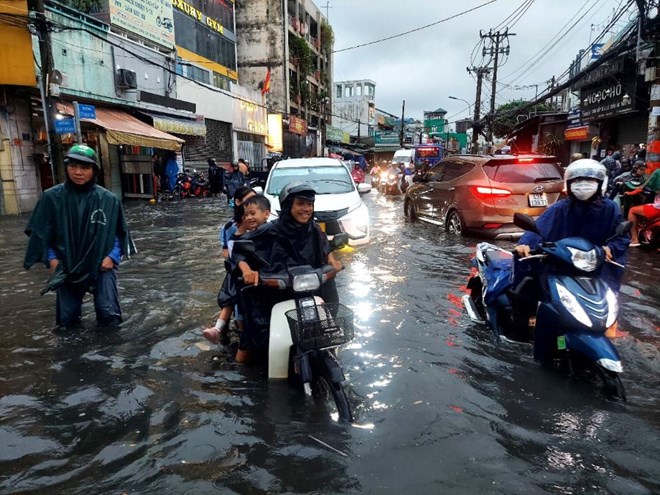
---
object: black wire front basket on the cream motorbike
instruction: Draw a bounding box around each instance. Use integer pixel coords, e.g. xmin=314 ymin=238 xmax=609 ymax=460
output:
xmin=285 ymin=303 xmax=355 ymax=351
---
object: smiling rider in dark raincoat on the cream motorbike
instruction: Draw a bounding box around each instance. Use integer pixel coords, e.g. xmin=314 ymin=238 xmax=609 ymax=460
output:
xmin=231 ymin=182 xmax=342 ymax=361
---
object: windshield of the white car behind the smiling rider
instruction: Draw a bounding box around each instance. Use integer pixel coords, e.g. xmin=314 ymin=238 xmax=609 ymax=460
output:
xmin=266 ymin=166 xmax=355 ymax=196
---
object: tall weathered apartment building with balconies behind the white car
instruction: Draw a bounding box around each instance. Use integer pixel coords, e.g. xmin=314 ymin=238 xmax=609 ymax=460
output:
xmin=236 ymin=0 xmax=334 ymax=157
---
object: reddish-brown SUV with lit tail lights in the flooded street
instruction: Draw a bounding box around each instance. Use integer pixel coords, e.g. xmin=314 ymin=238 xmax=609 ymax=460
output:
xmin=403 ymin=155 xmax=564 ymax=239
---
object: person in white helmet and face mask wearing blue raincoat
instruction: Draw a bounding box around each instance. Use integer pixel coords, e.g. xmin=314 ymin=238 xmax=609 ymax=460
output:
xmin=515 ymin=158 xmax=630 ymax=292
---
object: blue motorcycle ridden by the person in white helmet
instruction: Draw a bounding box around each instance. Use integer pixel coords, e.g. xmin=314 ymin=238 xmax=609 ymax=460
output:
xmin=463 ymin=213 xmax=631 ymax=400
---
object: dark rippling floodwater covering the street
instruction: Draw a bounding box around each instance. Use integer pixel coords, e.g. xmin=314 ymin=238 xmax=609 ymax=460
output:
xmin=0 ymin=188 xmax=660 ymax=495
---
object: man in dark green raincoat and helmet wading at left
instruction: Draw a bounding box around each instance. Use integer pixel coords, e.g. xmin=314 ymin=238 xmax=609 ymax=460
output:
xmin=23 ymin=144 xmax=136 ymax=327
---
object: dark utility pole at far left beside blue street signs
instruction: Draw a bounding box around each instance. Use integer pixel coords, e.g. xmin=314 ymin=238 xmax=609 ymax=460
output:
xmin=33 ymin=0 xmax=64 ymax=184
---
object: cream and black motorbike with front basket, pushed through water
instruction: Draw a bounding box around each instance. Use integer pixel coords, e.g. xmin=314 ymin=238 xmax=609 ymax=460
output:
xmin=233 ymin=234 xmax=354 ymax=422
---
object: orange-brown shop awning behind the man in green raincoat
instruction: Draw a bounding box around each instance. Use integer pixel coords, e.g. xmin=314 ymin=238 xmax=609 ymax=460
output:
xmin=57 ymin=103 xmax=184 ymax=151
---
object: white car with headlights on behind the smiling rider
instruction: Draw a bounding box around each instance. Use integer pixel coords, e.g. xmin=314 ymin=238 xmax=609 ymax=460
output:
xmin=264 ymin=158 xmax=371 ymax=246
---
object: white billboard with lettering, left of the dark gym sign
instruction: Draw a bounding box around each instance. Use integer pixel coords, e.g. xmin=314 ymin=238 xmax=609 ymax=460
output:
xmin=107 ymin=0 xmax=174 ymax=48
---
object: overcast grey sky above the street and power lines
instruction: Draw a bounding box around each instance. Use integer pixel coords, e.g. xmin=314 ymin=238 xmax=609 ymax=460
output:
xmin=328 ymin=0 xmax=634 ymax=128
